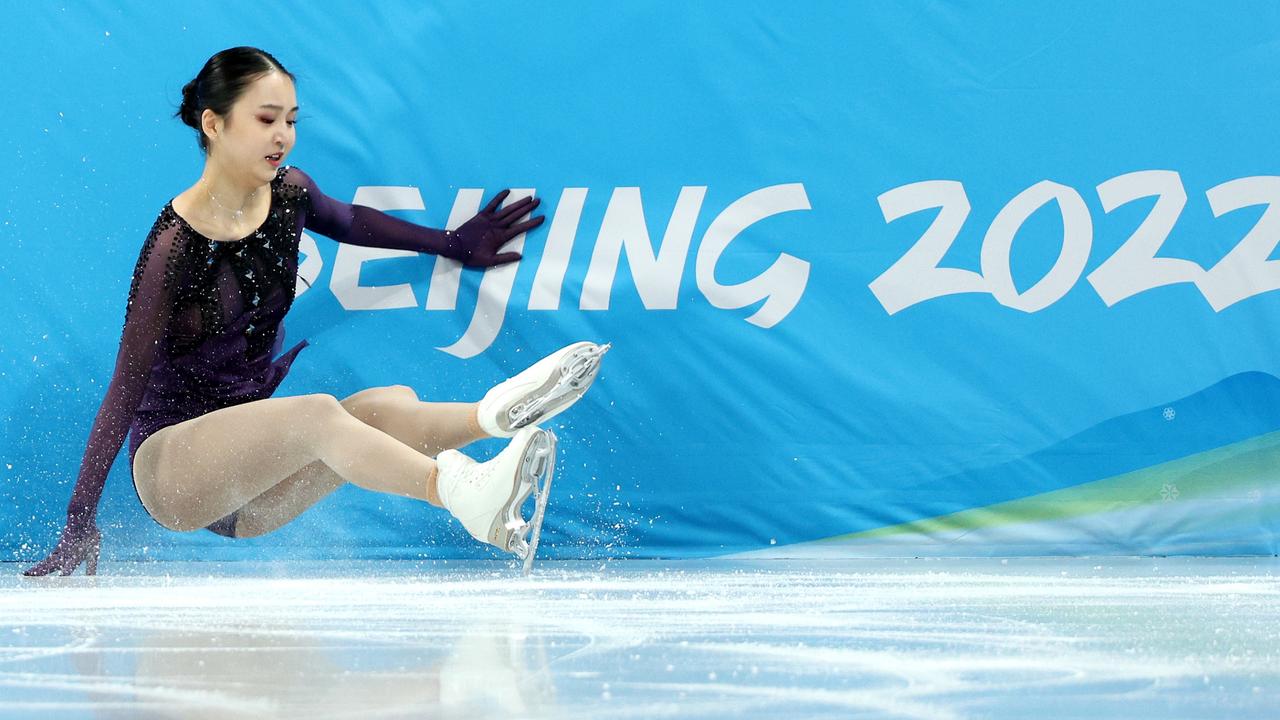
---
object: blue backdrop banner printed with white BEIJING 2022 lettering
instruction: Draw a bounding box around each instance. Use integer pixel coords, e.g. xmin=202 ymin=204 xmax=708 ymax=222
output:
xmin=0 ymin=0 xmax=1280 ymax=560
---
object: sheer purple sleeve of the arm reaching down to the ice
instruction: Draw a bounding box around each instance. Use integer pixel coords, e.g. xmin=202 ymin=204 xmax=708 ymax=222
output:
xmin=67 ymin=222 xmax=186 ymax=527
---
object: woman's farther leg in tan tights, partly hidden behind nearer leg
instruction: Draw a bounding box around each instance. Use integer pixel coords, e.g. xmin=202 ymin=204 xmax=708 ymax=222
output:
xmin=236 ymin=386 xmax=489 ymax=538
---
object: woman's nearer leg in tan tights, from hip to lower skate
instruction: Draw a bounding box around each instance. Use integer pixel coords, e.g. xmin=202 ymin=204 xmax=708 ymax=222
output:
xmin=134 ymin=395 xmax=436 ymax=530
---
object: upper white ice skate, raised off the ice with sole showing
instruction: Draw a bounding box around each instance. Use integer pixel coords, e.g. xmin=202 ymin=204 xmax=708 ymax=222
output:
xmin=476 ymin=342 xmax=611 ymax=437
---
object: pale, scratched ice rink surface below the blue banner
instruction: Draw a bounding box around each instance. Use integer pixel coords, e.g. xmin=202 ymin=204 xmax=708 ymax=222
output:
xmin=0 ymin=557 xmax=1280 ymax=720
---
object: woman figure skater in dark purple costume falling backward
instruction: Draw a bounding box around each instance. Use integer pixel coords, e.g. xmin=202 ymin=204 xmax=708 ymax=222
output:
xmin=26 ymin=47 xmax=608 ymax=575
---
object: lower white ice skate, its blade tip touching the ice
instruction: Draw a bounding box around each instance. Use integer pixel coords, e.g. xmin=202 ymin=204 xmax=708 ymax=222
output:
xmin=435 ymin=425 xmax=556 ymax=575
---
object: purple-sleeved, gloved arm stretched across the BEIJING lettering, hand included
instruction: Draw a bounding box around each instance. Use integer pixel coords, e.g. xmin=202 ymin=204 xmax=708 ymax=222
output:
xmin=285 ymin=168 xmax=545 ymax=268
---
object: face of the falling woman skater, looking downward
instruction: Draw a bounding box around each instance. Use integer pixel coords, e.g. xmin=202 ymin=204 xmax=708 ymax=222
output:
xmin=201 ymin=70 xmax=298 ymax=183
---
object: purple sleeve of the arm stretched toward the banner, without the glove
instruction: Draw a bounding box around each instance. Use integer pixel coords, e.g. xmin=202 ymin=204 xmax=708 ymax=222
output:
xmin=285 ymin=168 xmax=470 ymax=261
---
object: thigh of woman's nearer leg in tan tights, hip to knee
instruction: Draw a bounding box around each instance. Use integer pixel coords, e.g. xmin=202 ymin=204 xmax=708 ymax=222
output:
xmin=133 ymin=393 xmax=346 ymax=529
